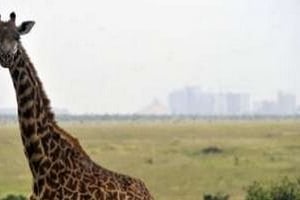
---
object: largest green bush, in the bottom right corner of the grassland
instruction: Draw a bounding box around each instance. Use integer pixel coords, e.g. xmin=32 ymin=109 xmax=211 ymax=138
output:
xmin=246 ymin=178 xmax=300 ymax=200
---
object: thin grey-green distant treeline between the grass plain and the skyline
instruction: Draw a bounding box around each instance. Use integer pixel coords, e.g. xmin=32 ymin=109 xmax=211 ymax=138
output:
xmin=0 ymin=114 xmax=300 ymax=122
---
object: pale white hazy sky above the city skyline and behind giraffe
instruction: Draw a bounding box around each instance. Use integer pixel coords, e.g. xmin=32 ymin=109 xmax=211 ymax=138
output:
xmin=0 ymin=0 xmax=300 ymax=113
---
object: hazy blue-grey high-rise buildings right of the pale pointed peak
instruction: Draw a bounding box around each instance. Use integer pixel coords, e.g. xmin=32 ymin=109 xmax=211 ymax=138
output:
xmin=169 ymin=87 xmax=297 ymax=116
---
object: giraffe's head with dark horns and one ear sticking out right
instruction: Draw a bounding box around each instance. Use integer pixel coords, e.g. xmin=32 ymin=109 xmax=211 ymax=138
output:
xmin=0 ymin=12 xmax=34 ymax=68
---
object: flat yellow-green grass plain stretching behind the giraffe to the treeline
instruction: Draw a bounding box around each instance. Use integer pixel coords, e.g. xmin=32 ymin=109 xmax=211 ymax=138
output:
xmin=0 ymin=120 xmax=300 ymax=200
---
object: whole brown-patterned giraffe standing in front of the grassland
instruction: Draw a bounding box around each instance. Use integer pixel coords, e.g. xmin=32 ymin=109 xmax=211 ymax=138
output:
xmin=0 ymin=12 xmax=154 ymax=200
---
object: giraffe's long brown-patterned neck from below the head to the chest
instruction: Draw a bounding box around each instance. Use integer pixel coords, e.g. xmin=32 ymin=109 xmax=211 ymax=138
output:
xmin=10 ymin=44 xmax=55 ymax=177
